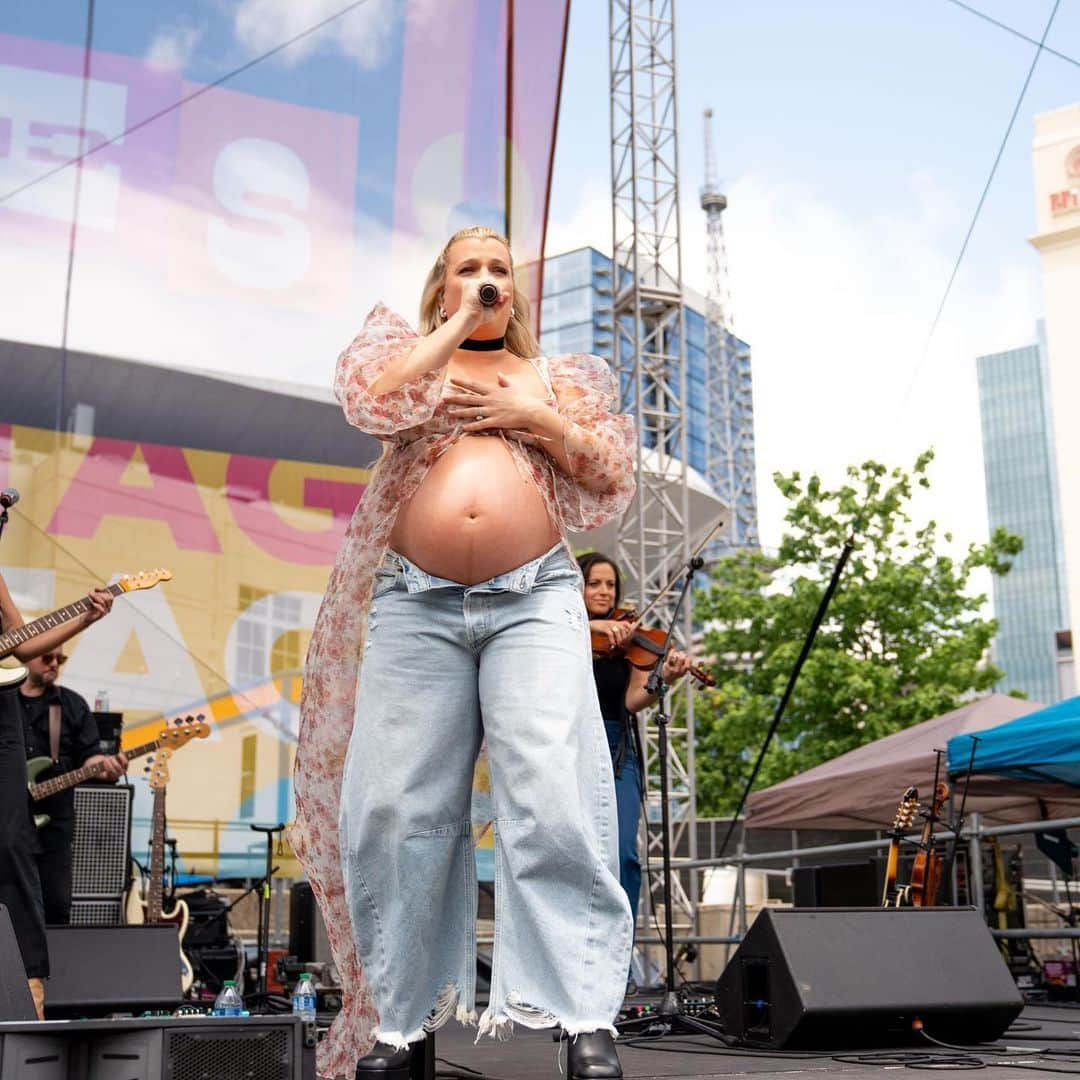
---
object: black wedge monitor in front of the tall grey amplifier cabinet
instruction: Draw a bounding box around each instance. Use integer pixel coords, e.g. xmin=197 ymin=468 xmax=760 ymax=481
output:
xmin=45 ymin=922 xmax=183 ymax=1018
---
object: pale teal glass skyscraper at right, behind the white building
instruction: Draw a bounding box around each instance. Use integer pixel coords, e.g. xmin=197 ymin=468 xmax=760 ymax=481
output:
xmin=977 ymin=326 xmax=1067 ymax=704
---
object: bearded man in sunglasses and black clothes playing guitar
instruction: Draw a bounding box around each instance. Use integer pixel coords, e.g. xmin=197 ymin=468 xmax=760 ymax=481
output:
xmin=18 ymin=648 xmax=127 ymax=923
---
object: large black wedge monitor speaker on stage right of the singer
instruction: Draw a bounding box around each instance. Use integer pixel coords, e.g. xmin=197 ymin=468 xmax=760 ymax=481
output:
xmin=716 ymin=907 xmax=1024 ymax=1049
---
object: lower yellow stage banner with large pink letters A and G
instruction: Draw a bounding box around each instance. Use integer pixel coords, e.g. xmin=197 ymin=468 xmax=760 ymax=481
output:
xmin=0 ymin=424 xmax=505 ymax=879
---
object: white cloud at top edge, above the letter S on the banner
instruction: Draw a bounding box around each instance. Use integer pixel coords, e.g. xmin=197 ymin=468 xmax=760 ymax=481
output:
xmin=233 ymin=0 xmax=437 ymax=70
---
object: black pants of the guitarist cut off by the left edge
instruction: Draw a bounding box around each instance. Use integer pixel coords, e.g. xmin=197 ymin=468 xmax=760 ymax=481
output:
xmin=0 ymin=690 xmax=49 ymax=978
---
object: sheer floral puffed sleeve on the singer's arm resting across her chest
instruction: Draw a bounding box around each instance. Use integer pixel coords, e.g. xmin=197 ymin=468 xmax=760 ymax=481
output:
xmin=548 ymin=354 xmax=636 ymax=530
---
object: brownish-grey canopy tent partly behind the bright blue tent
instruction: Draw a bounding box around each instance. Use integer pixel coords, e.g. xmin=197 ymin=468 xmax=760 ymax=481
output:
xmin=745 ymin=693 xmax=1080 ymax=829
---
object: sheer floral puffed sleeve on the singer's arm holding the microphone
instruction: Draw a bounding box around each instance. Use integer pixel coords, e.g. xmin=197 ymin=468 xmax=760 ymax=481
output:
xmin=334 ymin=303 xmax=446 ymax=438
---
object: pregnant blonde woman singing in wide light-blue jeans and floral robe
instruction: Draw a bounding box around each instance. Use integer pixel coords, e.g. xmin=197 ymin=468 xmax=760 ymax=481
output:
xmin=291 ymin=228 xmax=635 ymax=1080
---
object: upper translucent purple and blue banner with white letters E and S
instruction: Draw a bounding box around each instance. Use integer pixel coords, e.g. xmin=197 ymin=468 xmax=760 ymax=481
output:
xmin=0 ymin=0 xmax=568 ymax=388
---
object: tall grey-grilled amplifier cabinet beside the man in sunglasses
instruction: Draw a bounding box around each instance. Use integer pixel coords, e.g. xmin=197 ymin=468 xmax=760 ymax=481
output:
xmin=71 ymin=784 xmax=135 ymax=927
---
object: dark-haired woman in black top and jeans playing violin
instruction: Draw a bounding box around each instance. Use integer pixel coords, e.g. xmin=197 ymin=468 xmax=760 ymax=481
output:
xmin=578 ymin=552 xmax=691 ymax=976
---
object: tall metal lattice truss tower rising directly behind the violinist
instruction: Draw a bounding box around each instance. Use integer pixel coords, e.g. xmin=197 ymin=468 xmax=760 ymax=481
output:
xmin=609 ymin=0 xmax=697 ymax=923
